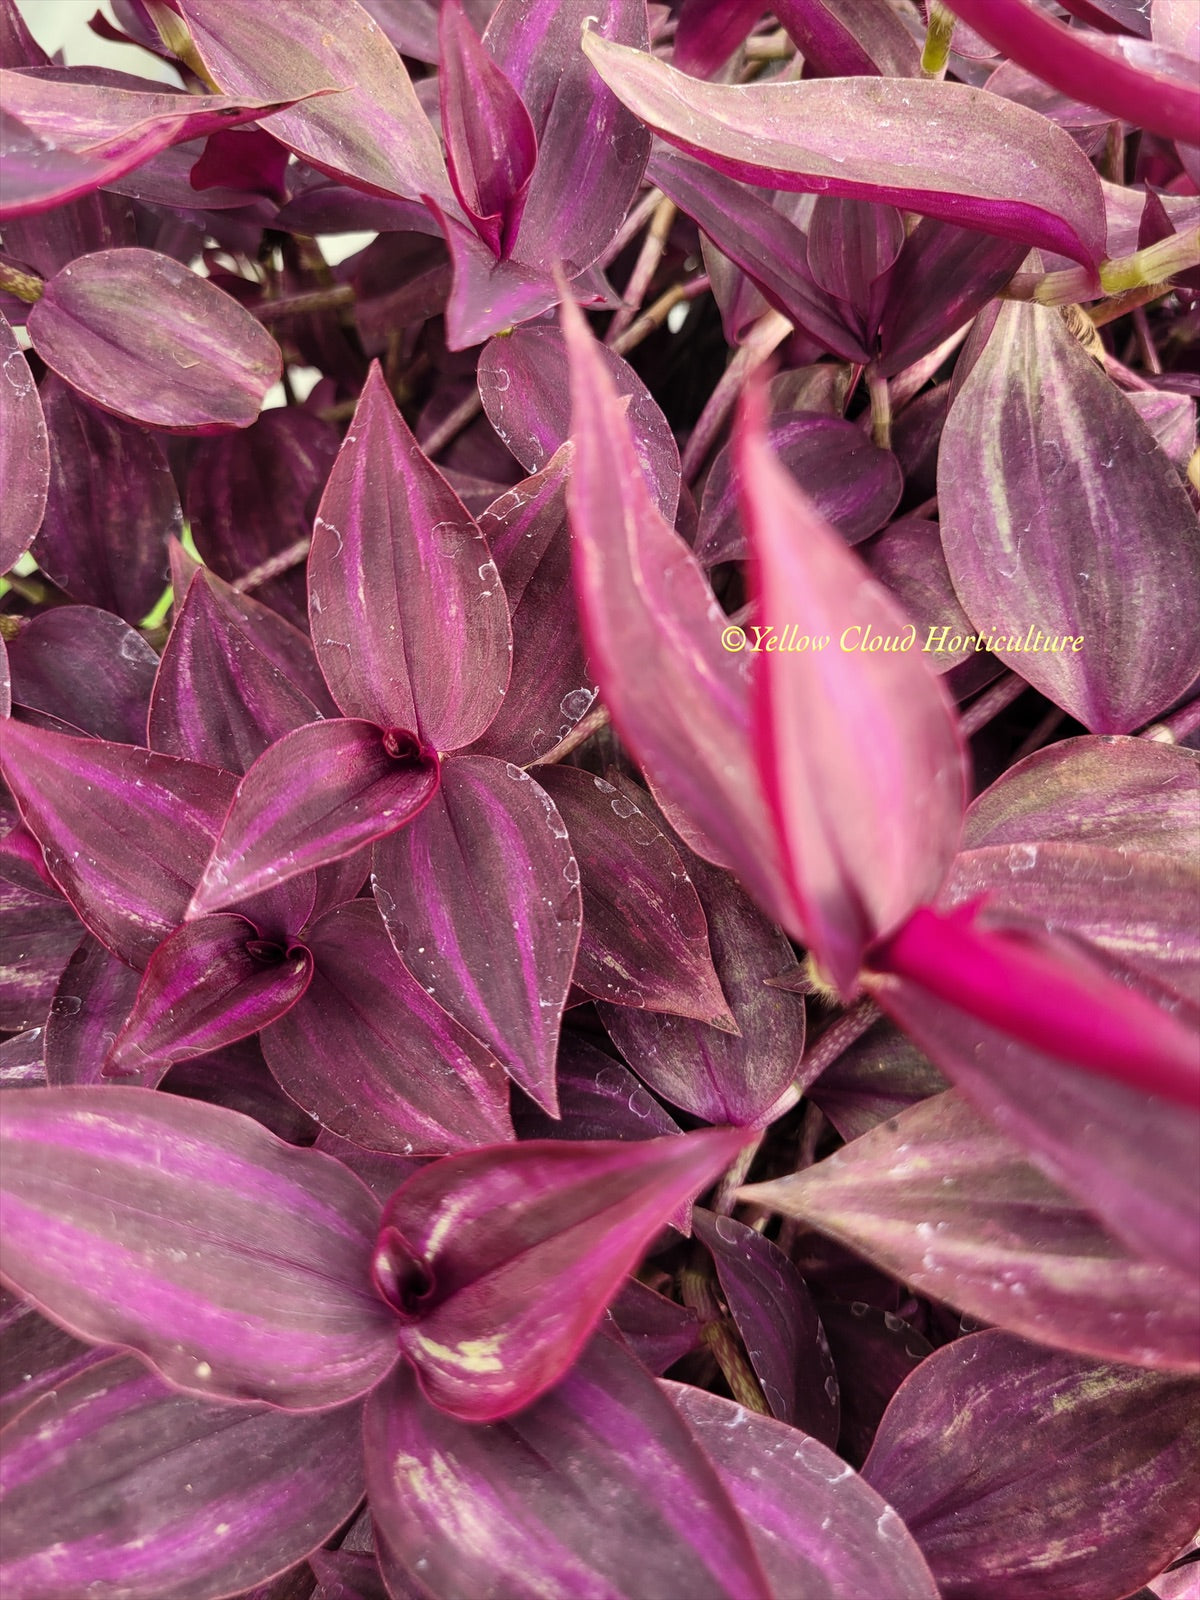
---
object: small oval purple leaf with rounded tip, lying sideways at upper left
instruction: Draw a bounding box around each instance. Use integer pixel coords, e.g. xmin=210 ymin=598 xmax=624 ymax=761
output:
xmin=27 ymin=250 xmax=282 ymax=434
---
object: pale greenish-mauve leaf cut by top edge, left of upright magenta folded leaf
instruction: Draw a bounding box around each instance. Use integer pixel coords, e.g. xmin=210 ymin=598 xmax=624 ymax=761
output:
xmin=178 ymin=0 xmax=450 ymax=200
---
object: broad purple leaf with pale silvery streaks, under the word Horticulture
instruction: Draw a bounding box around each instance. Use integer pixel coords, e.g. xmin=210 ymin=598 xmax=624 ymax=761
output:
xmin=938 ymin=302 xmax=1200 ymax=733
